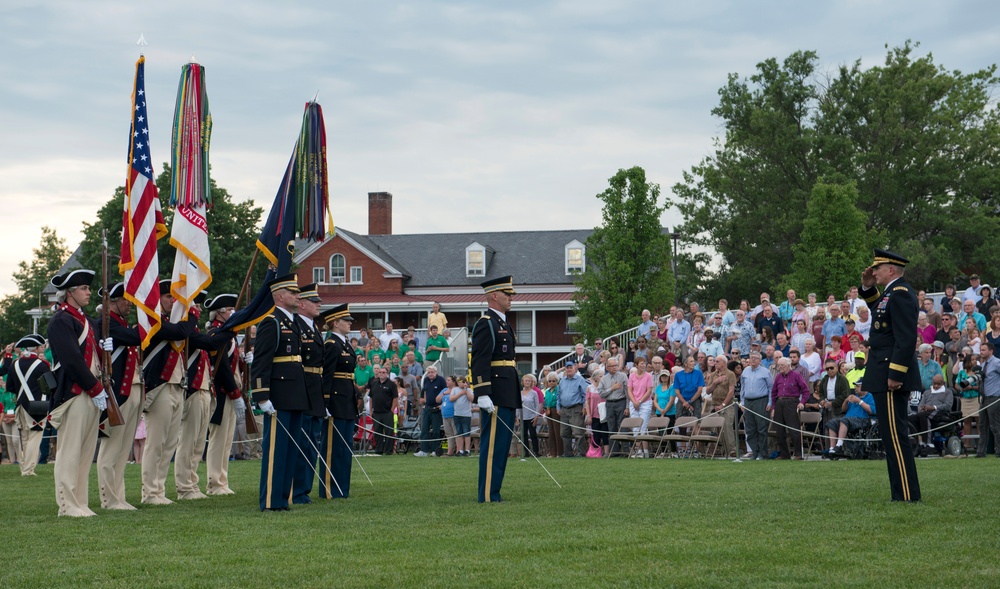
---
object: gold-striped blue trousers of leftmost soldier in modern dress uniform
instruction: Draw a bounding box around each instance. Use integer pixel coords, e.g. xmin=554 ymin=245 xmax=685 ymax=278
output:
xmin=260 ymin=411 xmax=302 ymax=510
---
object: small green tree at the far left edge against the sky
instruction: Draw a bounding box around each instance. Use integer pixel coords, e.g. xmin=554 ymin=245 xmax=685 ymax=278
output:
xmin=0 ymin=227 xmax=70 ymax=343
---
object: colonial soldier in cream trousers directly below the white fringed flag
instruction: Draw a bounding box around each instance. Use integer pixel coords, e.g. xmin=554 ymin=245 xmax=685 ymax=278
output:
xmin=142 ymin=280 xmax=198 ymax=505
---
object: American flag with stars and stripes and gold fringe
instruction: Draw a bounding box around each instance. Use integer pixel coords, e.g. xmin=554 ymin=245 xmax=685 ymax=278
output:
xmin=118 ymin=57 xmax=167 ymax=348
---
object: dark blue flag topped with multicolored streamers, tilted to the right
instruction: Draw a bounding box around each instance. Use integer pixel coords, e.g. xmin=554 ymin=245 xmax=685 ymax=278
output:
xmin=223 ymin=102 xmax=333 ymax=331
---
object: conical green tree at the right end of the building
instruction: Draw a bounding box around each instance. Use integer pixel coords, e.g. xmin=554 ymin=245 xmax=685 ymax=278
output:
xmin=574 ymin=166 xmax=674 ymax=340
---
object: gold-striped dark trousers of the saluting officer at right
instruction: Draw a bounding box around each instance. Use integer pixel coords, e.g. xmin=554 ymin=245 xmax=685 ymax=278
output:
xmin=872 ymin=390 xmax=920 ymax=501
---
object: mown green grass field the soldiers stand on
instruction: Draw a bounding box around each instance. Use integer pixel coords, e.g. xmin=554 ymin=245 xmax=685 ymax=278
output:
xmin=0 ymin=456 xmax=1000 ymax=588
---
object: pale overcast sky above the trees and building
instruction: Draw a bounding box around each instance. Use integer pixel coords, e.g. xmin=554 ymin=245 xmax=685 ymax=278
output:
xmin=0 ymin=0 xmax=1000 ymax=294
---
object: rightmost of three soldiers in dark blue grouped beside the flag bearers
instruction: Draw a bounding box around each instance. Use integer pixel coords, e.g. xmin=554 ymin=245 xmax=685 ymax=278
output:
xmin=319 ymin=305 xmax=361 ymax=499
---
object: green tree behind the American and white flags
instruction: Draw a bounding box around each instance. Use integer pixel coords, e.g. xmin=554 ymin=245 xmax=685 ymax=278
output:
xmin=80 ymin=163 xmax=266 ymax=303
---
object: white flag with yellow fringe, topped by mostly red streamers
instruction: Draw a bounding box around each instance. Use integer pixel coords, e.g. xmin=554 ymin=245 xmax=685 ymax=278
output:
xmin=170 ymin=63 xmax=212 ymax=336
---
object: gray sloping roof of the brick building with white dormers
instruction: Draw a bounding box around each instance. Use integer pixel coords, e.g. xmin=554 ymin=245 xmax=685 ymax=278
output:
xmin=296 ymin=227 xmax=594 ymax=287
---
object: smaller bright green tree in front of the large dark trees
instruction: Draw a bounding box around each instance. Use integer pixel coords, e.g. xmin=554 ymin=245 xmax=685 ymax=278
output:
xmin=781 ymin=180 xmax=873 ymax=297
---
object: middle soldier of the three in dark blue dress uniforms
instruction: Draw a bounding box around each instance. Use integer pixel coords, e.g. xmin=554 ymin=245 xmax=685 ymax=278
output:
xmin=292 ymin=283 xmax=326 ymax=503
